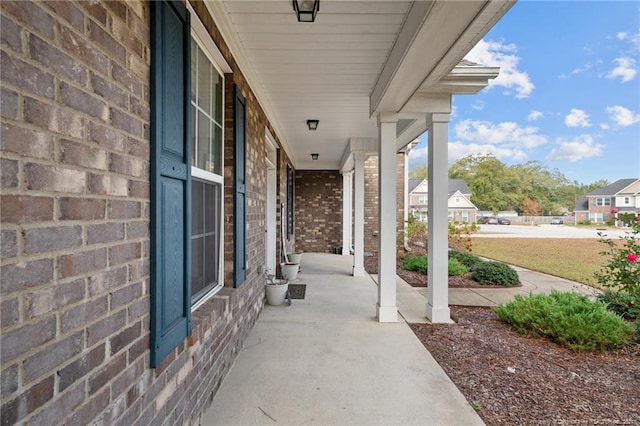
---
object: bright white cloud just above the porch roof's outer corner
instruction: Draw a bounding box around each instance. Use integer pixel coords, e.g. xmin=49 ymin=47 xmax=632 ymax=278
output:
xmin=466 ymin=40 xmax=535 ymax=98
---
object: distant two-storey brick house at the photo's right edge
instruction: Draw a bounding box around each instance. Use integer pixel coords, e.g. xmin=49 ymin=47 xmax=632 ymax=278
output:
xmin=574 ymin=179 xmax=640 ymax=223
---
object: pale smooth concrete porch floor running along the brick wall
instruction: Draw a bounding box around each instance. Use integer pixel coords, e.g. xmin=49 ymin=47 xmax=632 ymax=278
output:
xmin=201 ymin=253 xmax=484 ymax=425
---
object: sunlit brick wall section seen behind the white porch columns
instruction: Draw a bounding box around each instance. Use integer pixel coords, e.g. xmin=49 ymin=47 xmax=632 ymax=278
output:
xmin=364 ymin=154 xmax=404 ymax=255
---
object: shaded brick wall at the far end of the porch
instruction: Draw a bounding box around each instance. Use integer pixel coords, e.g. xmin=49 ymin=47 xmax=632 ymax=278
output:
xmin=295 ymin=170 xmax=342 ymax=253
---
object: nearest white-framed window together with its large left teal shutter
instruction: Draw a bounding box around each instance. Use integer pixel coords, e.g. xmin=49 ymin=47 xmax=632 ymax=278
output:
xmin=150 ymin=1 xmax=231 ymax=367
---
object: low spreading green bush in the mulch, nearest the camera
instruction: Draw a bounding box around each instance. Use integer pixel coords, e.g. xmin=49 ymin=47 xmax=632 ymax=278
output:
xmin=493 ymin=291 xmax=633 ymax=351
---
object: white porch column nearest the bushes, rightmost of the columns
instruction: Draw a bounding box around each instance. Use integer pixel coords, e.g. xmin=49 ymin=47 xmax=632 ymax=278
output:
xmin=427 ymin=113 xmax=451 ymax=323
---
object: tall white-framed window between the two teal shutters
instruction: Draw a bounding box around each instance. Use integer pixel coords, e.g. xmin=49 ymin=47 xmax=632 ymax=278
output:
xmin=191 ymin=36 xmax=224 ymax=307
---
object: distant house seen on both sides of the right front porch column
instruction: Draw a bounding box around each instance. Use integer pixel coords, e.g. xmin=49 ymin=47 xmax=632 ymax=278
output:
xmin=408 ymin=179 xmax=478 ymax=222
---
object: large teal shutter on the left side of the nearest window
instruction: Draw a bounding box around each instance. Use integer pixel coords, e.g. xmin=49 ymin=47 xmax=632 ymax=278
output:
xmin=151 ymin=1 xmax=191 ymax=367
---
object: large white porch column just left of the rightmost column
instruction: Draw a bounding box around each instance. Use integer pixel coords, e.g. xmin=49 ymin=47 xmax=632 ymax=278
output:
xmin=377 ymin=114 xmax=398 ymax=322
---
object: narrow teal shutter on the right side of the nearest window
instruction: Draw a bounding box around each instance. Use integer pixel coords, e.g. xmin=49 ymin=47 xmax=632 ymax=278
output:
xmin=233 ymin=86 xmax=247 ymax=287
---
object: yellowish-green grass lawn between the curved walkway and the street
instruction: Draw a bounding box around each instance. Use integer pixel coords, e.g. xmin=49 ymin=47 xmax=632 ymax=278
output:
xmin=473 ymin=238 xmax=620 ymax=288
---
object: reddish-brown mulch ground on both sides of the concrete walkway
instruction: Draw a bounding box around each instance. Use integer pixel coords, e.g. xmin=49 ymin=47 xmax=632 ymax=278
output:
xmin=365 ymin=257 xmax=640 ymax=426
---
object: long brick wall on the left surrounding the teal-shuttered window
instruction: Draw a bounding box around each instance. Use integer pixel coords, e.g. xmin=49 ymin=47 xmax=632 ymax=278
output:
xmin=0 ymin=1 xmax=288 ymax=425
